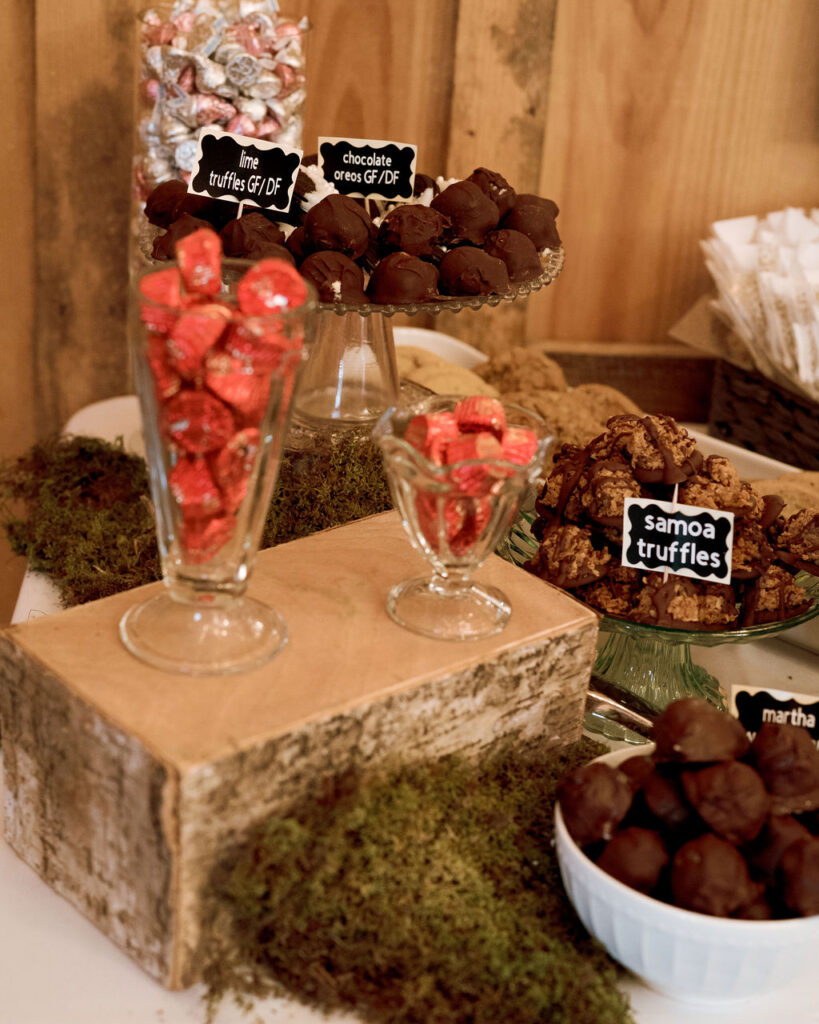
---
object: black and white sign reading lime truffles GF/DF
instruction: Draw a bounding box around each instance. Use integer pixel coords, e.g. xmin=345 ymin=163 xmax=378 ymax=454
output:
xmin=187 ymin=128 xmax=301 ymax=211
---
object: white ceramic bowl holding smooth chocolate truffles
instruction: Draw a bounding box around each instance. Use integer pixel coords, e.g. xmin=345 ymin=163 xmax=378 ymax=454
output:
xmin=555 ymin=743 xmax=819 ymax=1005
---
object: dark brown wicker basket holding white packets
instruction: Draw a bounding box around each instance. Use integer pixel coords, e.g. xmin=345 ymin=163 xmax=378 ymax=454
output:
xmin=708 ymin=359 xmax=819 ymax=469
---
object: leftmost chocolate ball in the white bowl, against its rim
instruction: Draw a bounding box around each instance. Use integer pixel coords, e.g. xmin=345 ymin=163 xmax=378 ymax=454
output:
xmin=557 ymin=761 xmax=632 ymax=846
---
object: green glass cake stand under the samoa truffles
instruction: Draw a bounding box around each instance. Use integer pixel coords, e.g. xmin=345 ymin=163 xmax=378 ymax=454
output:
xmin=498 ymin=507 xmax=819 ymax=742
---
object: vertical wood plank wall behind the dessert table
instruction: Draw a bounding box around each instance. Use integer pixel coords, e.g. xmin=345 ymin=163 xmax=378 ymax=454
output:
xmin=0 ymin=0 xmax=819 ymax=622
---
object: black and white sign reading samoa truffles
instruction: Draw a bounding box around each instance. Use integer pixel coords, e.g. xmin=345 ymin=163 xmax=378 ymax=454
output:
xmin=621 ymin=498 xmax=734 ymax=583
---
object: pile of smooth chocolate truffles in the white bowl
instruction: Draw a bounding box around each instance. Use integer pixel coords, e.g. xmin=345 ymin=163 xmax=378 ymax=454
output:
xmin=558 ymin=697 xmax=819 ymax=921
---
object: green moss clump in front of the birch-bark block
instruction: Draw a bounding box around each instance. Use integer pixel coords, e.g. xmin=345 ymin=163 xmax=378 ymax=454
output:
xmin=207 ymin=742 xmax=632 ymax=1024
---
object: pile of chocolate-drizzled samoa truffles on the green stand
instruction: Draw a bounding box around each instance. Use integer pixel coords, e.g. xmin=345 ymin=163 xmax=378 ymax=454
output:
xmin=524 ymin=414 xmax=819 ymax=630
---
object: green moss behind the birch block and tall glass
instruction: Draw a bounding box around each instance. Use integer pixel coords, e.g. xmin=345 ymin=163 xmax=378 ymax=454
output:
xmin=0 ymin=432 xmax=391 ymax=606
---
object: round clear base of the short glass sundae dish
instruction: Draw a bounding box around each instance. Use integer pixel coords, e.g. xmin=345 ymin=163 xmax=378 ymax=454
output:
xmin=387 ymin=577 xmax=512 ymax=640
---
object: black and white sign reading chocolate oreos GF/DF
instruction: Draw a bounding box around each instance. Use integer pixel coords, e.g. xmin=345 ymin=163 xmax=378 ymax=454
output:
xmin=318 ymin=137 xmax=418 ymax=200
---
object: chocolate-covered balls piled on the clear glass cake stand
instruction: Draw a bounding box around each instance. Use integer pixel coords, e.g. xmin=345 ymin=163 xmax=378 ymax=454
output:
xmin=145 ymin=157 xmax=560 ymax=305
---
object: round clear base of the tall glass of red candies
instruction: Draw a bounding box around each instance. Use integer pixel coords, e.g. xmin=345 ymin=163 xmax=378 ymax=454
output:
xmin=120 ymin=593 xmax=288 ymax=675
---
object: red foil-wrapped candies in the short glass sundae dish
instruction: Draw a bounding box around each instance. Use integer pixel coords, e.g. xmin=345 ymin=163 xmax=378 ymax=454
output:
xmin=403 ymin=395 xmax=537 ymax=557
